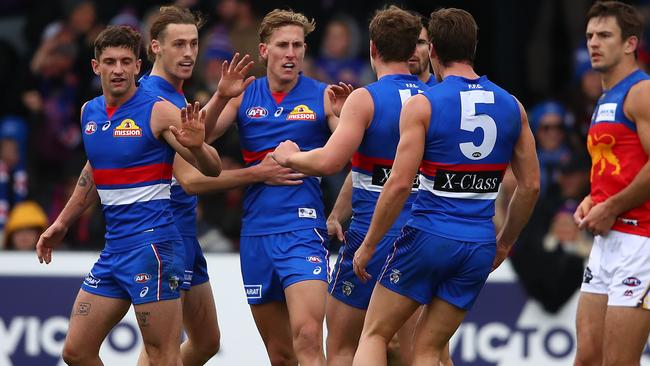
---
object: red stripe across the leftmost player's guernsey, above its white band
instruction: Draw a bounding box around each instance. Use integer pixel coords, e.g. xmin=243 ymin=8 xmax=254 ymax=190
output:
xmin=93 ymin=163 xmax=172 ymax=185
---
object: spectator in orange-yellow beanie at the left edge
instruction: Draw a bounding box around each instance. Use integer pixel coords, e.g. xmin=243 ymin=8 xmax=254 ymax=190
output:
xmin=4 ymin=201 xmax=48 ymax=251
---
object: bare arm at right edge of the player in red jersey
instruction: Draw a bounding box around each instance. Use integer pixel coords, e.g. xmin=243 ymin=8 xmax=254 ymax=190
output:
xmin=580 ymin=81 xmax=650 ymax=235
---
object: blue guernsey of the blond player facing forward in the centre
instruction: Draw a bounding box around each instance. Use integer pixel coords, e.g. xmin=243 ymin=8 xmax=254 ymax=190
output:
xmin=237 ymin=75 xmax=330 ymax=236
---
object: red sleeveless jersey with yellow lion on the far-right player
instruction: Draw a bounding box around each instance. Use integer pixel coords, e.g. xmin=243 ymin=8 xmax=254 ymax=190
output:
xmin=587 ymin=70 xmax=650 ymax=237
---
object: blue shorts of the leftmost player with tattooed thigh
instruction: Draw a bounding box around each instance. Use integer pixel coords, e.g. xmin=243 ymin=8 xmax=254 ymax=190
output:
xmin=81 ymin=240 xmax=185 ymax=305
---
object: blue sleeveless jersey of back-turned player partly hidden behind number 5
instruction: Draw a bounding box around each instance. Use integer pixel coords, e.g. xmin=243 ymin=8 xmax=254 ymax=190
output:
xmin=350 ymin=75 xmax=428 ymax=236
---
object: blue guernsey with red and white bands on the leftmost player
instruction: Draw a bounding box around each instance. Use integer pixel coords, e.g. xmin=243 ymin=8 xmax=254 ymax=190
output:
xmin=81 ymin=88 xmax=180 ymax=253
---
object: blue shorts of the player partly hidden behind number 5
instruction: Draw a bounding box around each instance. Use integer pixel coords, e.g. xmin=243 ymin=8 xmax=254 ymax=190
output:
xmin=328 ymin=230 xmax=397 ymax=310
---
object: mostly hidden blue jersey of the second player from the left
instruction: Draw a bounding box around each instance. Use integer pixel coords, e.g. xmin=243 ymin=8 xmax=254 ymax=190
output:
xmin=140 ymin=75 xmax=198 ymax=236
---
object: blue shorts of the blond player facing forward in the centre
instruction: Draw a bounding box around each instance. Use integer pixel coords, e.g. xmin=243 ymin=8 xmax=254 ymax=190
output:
xmin=239 ymin=229 xmax=329 ymax=305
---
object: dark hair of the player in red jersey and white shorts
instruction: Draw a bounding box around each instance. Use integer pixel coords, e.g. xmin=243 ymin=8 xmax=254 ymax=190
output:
xmin=587 ymin=1 xmax=643 ymax=41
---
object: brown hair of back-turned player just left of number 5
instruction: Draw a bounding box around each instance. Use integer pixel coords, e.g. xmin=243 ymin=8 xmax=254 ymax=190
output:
xmin=368 ymin=5 xmax=422 ymax=62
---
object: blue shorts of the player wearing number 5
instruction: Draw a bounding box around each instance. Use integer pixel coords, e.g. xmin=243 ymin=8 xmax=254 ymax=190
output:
xmin=380 ymin=226 xmax=496 ymax=310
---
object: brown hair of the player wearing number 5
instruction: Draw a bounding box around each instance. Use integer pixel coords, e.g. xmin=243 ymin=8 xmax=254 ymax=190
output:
xmin=427 ymin=8 xmax=478 ymax=66
